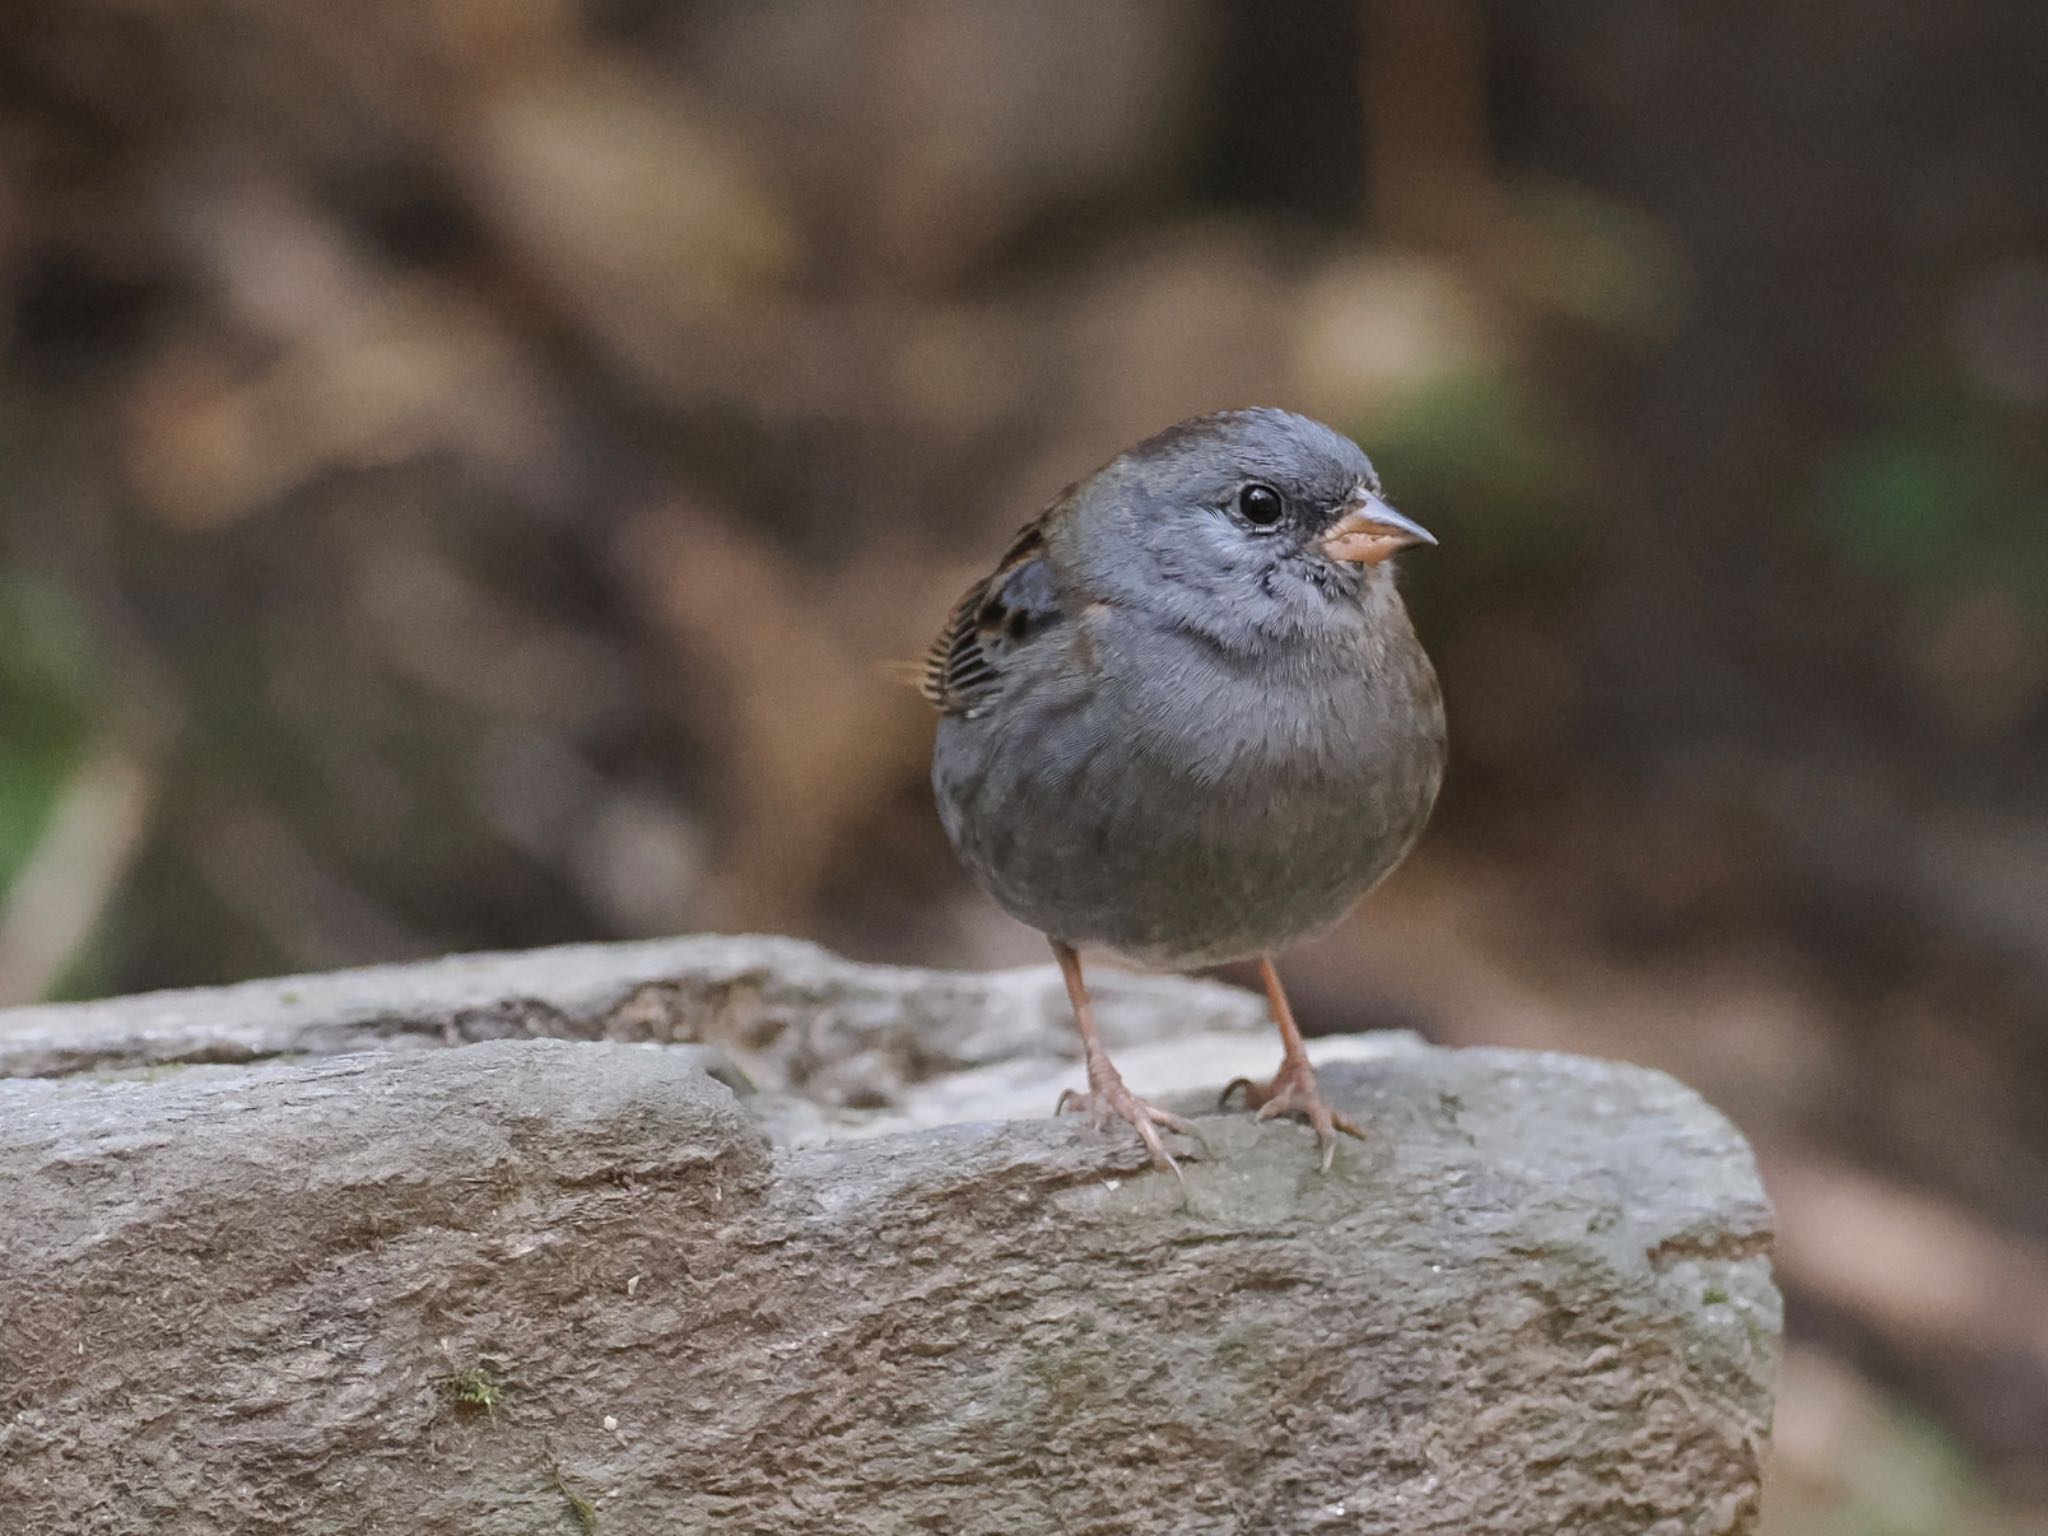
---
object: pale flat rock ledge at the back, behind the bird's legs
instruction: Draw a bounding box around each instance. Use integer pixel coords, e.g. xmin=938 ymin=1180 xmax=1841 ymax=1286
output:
xmin=0 ymin=936 xmax=1266 ymax=1102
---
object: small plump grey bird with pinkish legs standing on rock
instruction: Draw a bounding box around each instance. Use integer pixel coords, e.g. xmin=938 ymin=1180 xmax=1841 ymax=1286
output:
xmin=924 ymin=410 xmax=1444 ymax=1176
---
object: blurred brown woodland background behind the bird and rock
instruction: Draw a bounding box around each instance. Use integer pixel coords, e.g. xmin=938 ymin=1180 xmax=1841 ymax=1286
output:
xmin=0 ymin=0 xmax=2048 ymax=1536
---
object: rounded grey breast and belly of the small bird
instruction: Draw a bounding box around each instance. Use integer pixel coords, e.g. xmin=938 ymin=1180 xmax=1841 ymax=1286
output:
xmin=934 ymin=589 xmax=1442 ymax=965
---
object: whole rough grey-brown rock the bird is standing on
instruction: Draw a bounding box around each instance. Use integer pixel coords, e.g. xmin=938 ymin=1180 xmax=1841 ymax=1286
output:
xmin=0 ymin=940 xmax=1778 ymax=1536
